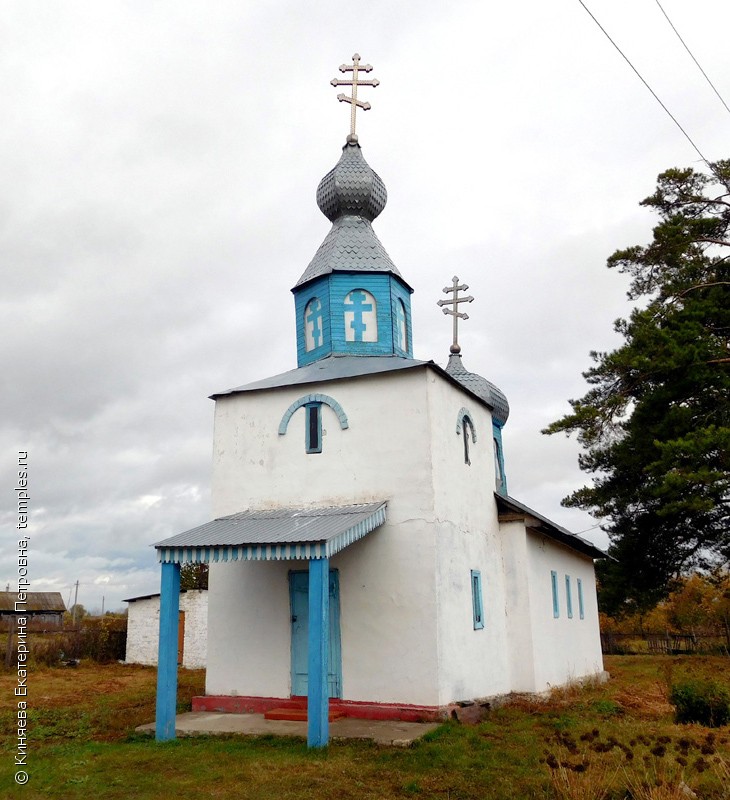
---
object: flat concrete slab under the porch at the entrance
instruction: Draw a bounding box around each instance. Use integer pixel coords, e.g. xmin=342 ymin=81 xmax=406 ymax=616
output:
xmin=137 ymin=711 xmax=438 ymax=747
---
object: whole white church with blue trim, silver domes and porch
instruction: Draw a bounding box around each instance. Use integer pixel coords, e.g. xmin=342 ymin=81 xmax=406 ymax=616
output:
xmin=155 ymin=59 xmax=604 ymax=746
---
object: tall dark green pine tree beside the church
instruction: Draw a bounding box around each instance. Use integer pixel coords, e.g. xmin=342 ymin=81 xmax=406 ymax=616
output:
xmin=544 ymin=160 xmax=730 ymax=613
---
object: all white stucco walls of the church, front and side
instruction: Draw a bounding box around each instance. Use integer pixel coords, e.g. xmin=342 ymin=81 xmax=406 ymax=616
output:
xmin=206 ymin=368 xmax=601 ymax=706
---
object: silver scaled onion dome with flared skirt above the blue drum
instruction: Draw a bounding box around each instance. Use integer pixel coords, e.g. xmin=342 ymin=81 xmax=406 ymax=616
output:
xmin=294 ymin=142 xmax=405 ymax=289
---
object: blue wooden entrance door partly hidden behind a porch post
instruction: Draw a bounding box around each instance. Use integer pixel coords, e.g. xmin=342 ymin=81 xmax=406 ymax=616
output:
xmin=289 ymin=570 xmax=342 ymax=697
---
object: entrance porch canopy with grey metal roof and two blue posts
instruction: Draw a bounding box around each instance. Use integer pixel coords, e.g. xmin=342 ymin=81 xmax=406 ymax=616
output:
xmin=149 ymin=500 xmax=387 ymax=747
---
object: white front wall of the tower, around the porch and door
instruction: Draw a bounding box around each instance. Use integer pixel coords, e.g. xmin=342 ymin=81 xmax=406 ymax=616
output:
xmin=206 ymin=369 xmax=439 ymax=705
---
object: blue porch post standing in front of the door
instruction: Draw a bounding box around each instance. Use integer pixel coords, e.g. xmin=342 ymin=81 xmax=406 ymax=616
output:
xmin=307 ymin=558 xmax=330 ymax=747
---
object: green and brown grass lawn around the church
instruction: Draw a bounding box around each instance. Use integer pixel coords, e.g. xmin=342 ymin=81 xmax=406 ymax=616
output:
xmin=0 ymin=656 xmax=730 ymax=800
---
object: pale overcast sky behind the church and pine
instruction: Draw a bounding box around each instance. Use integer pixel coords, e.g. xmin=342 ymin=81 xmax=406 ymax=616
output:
xmin=0 ymin=0 xmax=730 ymax=609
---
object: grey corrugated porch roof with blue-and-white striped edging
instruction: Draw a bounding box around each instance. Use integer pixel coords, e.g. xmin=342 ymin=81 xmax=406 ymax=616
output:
xmin=155 ymin=501 xmax=386 ymax=562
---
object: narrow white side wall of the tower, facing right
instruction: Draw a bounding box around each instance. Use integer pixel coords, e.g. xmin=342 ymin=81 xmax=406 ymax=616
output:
xmin=420 ymin=373 xmax=510 ymax=705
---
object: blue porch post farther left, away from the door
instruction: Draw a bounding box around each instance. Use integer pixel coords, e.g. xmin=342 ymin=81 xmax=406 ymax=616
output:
xmin=155 ymin=563 xmax=180 ymax=742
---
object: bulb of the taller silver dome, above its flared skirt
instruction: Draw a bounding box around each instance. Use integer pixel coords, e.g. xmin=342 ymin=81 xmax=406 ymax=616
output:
xmin=317 ymin=142 xmax=388 ymax=222
